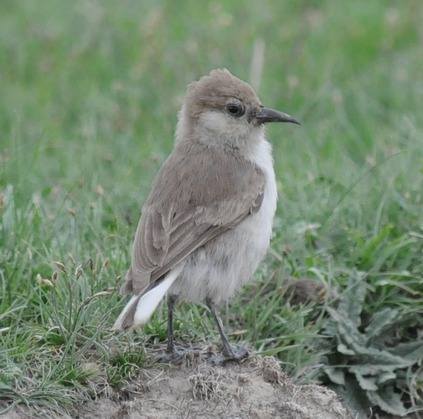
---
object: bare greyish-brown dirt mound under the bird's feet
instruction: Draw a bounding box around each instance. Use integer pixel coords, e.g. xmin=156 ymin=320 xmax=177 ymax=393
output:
xmin=77 ymin=355 xmax=351 ymax=419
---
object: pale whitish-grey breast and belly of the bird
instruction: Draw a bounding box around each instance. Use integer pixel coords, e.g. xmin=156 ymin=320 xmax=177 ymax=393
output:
xmin=170 ymin=154 xmax=277 ymax=304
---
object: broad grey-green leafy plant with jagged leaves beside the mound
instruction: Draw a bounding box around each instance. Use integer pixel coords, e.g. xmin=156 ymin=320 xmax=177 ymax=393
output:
xmin=324 ymin=273 xmax=423 ymax=416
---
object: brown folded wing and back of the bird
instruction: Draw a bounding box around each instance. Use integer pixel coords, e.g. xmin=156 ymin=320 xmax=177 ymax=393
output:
xmin=122 ymin=144 xmax=265 ymax=294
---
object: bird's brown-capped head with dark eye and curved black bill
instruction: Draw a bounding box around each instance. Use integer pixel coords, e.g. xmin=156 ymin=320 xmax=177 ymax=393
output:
xmin=177 ymin=69 xmax=299 ymax=145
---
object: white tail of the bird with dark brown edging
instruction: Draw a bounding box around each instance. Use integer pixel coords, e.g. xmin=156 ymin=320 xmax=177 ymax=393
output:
xmin=113 ymin=269 xmax=180 ymax=330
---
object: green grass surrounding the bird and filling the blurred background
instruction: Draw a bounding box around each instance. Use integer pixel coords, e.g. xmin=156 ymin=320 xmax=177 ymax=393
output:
xmin=0 ymin=0 xmax=423 ymax=416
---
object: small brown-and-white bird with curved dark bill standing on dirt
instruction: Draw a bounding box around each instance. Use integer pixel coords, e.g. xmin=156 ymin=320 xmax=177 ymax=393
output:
xmin=113 ymin=69 xmax=300 ymax=360
